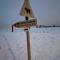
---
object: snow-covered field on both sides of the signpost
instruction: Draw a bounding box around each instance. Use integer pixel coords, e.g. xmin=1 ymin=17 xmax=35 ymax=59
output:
xmin=0 ymin=27 xmax=60 ymax=60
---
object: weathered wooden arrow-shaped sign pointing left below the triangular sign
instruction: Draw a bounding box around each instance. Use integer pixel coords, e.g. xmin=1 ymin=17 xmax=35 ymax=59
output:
xmin=14 ymin=19 xmax=37 ymax=28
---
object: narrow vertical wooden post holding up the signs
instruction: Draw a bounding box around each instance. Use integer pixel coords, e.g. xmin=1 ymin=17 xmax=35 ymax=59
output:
xmin=25 ymin=17 xmax=31 ymax=60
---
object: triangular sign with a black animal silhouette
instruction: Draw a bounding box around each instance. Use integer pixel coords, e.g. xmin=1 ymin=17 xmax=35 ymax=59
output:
xmin=20 ymin=0 xmax=35 ymax=18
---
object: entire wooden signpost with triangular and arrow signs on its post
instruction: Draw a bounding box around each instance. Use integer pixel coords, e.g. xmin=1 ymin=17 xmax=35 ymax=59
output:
xmin=12 ymin=0 xmax=37 ymax=60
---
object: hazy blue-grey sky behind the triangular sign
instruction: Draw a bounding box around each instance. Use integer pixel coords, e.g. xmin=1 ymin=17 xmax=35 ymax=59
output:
xmin=0 ymin=0 xmax=60 ymax=25
